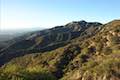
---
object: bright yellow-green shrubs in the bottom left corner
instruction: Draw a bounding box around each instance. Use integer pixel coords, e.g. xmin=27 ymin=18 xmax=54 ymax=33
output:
xmin=0 ymin=64 xmax=56 ymax=80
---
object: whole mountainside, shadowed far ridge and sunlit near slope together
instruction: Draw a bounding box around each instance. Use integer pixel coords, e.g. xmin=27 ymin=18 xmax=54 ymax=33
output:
xmin=0 ymin=20 xmax=120 ymax=80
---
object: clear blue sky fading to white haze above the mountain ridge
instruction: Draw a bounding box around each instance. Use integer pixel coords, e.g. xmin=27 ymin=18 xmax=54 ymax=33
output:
xmin=0 ymin=0 xmax=120 ymax=30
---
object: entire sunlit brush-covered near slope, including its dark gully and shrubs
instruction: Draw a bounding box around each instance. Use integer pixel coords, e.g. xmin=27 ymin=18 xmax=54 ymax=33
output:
xmin=0 ymin=20 xmax=120 ymax=80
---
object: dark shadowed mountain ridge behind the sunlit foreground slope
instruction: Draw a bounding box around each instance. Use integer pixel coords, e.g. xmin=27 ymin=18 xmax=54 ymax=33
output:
xmin=0 ymin=21 xmax=102 ymax=66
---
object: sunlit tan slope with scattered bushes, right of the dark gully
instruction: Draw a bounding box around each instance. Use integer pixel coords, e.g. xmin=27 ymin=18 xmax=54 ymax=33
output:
xmin=62 ymin=20 xmax=120 ymax=80
